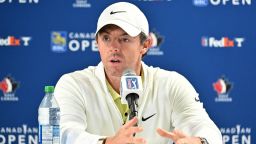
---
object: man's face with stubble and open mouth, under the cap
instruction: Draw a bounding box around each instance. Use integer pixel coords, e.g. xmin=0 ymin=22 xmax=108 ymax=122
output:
xmin=97 ymin=25 xmax=147 ymax=77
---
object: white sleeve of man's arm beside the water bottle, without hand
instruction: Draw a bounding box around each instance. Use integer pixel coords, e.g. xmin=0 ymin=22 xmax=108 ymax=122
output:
xmin=54 ymin=75 xmax=104 ymax=144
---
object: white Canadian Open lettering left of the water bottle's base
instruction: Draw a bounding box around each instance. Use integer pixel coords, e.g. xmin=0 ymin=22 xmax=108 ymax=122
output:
xmin=0 ymin=124 xmax=38 ymax=144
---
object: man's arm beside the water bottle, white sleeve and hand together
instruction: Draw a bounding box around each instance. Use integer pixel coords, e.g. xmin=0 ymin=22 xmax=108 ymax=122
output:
xmin=54 ymin=75 xmax=146 ymax=144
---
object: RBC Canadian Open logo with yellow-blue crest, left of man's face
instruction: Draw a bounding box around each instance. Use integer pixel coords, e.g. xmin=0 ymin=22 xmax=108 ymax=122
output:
xmin=51 ymin=31 xmax=98 ymax=53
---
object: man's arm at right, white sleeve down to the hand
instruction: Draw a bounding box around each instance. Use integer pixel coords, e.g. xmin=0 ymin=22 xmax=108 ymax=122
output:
xmin=160 ymin=73 xmax=222 ymax=144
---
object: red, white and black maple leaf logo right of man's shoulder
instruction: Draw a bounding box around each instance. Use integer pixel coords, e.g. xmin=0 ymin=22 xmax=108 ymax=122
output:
xmin=213 ymin=76 xmax=233 ymax=102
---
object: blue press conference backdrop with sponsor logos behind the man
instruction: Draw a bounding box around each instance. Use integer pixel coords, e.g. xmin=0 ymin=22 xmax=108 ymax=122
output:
xmin=0 ymin=0 xmax=256 ymax=144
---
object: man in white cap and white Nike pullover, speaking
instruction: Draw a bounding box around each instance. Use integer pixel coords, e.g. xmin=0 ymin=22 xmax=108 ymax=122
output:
xmin=55 ymin=2 xmax=222 ymax=144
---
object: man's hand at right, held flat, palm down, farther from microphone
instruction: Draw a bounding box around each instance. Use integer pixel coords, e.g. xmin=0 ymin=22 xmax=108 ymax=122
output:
xmin=157 ymin=128 xmax=201 ymax=144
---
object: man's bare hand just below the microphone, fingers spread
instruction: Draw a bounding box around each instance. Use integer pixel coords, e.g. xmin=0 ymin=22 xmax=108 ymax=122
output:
xmin=106 ymin=117 xmax=146 ymax=144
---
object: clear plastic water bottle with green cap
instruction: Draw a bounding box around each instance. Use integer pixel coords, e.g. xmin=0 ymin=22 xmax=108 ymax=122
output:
xmin=38 ymin=86 xmax=60 ymax=144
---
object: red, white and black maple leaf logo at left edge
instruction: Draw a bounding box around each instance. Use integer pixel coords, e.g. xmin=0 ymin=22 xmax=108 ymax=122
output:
xmin=0 ymin=76 xmax=19 ymax=101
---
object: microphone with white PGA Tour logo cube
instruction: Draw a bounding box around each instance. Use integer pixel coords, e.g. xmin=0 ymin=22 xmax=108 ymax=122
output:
xmin=120 ymin=69 xmax=143 ymax=121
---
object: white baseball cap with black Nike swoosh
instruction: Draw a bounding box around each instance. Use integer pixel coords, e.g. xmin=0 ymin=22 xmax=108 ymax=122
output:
xmin=96 ymin=2 xmax=149 ymax=37
